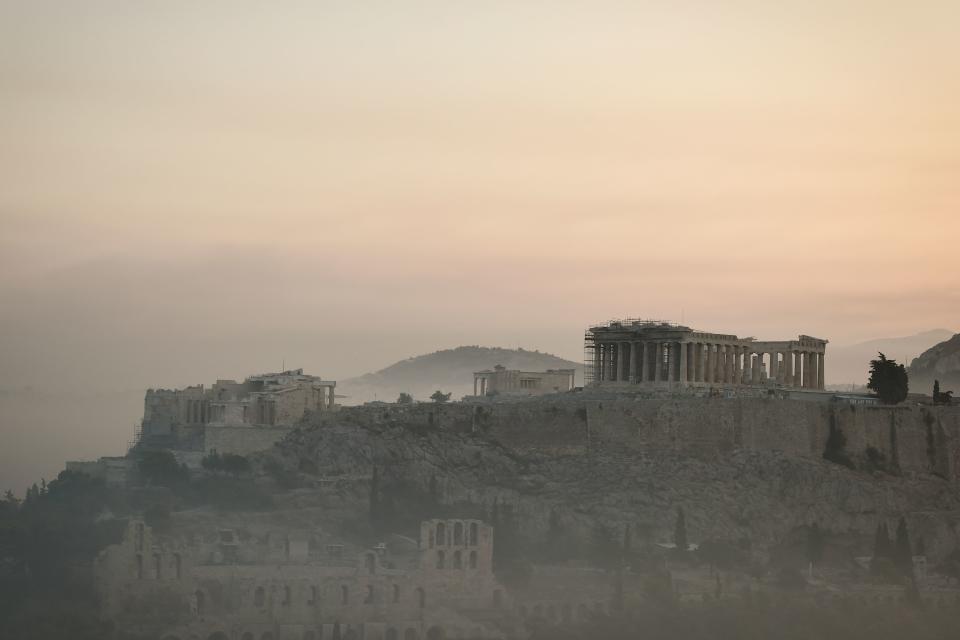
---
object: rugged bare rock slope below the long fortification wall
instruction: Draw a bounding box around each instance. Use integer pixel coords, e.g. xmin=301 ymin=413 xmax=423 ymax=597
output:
xmin=258 ymin=400 xmax=960 ymax=562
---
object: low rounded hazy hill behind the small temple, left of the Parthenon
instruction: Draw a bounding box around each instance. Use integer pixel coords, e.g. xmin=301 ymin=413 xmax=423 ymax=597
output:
xmin=337 ymin=346 xmax=583 ymax=404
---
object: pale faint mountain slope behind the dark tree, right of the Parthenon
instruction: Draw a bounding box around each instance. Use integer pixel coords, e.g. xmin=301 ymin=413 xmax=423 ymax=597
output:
xmin=826 ymin=329 xmax=953 ymax=385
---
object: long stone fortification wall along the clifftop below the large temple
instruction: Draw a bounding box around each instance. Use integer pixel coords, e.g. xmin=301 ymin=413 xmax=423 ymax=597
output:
xmin=330 ymin=392 xmax=960 ymax=480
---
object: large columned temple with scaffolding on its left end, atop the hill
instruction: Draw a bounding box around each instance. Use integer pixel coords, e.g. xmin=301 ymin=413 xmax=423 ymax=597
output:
xmin=584 ymin=319 xmax=827 ymax=389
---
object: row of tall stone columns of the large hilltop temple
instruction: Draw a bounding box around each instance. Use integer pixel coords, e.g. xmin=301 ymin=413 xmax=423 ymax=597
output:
xmin=594 ymin=341 xmax=824 ymax=389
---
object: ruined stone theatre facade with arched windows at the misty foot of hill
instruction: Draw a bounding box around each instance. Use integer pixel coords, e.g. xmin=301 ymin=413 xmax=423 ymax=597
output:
xmin=95 ymin=520 xmax=609 ymax=640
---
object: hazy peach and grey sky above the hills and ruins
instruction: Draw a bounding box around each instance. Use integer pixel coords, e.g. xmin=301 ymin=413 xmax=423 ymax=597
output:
xmin=0 ymin=0 xmax=960 ymax=396
